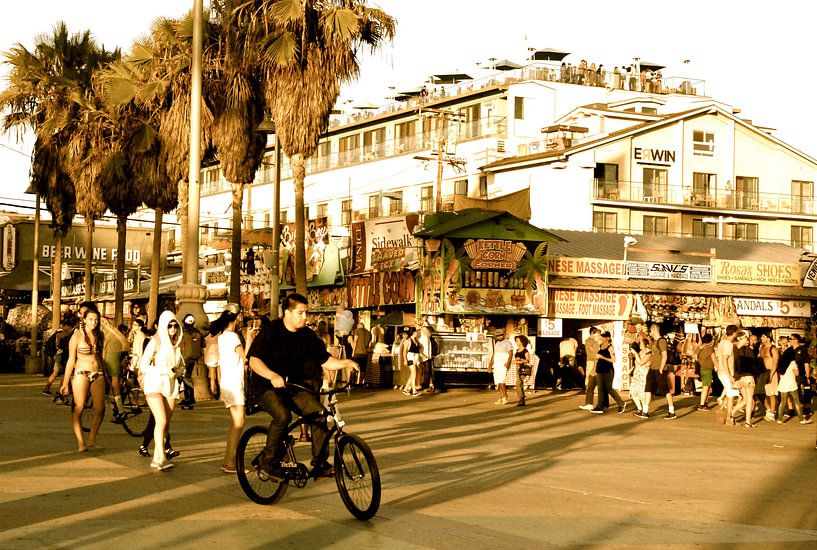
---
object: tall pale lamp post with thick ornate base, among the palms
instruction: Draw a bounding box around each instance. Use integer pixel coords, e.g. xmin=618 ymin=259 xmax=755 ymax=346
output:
xmin=175 ymin=0 xmax=209 ymax=326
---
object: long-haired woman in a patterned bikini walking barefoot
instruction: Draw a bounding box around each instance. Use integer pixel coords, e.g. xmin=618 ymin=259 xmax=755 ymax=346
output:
xmin=60 ymin=304 xmax=105 ymax=453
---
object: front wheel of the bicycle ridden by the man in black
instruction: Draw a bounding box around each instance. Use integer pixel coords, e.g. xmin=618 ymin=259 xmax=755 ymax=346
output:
xmin=335 ymin=434 xmax=380 ymax=520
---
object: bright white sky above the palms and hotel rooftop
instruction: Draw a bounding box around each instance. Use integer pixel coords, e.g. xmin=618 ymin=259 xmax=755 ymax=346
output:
xmin=0 ymin=0 xmax=817 ymax=216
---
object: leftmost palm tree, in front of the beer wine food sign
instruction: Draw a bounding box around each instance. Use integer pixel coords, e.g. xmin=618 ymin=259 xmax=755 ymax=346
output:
xmin=0 ymin=23 xmax=110 ymax=329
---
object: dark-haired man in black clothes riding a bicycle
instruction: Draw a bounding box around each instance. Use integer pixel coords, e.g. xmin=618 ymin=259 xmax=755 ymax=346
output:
xmin=247 ymin=294 xmax=359 ymax=481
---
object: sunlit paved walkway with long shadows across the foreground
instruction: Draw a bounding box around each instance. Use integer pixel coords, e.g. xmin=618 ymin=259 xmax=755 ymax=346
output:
xmin=0 ymin=374 xmax=817 ymax=550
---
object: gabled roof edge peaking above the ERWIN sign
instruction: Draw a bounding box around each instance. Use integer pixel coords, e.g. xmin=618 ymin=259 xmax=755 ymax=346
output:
xmin=480 ymin=103 xmax=817 ymax=170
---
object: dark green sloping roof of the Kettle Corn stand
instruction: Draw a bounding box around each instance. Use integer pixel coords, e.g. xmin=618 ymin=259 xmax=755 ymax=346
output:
xmin=414 ymin=209 xmax=561 ymax=242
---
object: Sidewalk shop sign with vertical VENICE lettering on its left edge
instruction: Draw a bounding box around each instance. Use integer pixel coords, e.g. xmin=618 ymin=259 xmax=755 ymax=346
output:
xmin=351 ymin=214 xmax=420 ymax=273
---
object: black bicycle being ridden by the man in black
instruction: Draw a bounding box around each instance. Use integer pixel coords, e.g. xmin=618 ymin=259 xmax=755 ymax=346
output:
xmin=236 ymin=382 xmax=381 ymax=521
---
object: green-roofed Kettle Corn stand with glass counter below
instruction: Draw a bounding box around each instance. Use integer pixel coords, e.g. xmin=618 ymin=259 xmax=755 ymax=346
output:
xmin=415 ymin=210 xmax=561 ymax=384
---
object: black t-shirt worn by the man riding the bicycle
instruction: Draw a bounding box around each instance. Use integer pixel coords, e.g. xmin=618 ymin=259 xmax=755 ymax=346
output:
xmin=247 ymin=319 xmax=329 ymax=393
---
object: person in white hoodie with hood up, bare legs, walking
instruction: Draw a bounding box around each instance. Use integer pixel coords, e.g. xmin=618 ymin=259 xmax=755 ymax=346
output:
xmin=139 ymin=311 xmax=184 ymax=471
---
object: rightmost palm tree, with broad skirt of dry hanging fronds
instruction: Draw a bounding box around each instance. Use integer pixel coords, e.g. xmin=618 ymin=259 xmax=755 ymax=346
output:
xmin=239 ymin=0 xmax=395 ymax=294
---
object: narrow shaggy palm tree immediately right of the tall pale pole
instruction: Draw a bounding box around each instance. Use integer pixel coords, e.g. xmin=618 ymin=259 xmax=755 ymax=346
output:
xmin=211 ymin=0 xmax=266 ymax=303
